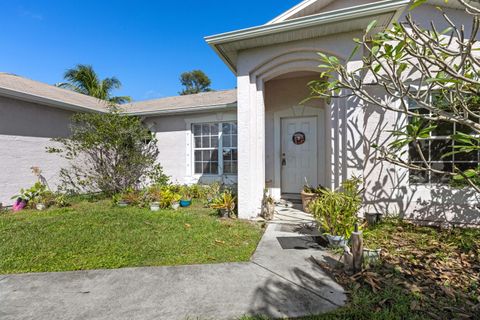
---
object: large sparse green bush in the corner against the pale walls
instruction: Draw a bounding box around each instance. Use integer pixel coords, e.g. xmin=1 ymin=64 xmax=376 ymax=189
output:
xmin=48 ymin=111 xmax=163 ymax=196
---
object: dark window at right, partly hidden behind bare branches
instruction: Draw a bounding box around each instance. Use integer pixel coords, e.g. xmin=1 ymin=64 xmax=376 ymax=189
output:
xmin=409 ymin=97 xmax=480 ymax=184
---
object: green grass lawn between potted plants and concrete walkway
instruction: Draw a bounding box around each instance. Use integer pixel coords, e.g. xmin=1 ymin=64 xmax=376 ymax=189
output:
xmin=0 ymin=200 xmax=262 ymax=274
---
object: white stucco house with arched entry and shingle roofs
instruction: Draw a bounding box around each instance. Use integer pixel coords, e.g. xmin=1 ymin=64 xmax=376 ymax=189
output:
xmin=0 ymin=0 xmax=480 ymax=224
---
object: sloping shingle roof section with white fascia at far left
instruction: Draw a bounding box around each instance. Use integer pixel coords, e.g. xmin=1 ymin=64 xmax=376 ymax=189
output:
xmin=0 ymin=73 xmax=108 ymax=111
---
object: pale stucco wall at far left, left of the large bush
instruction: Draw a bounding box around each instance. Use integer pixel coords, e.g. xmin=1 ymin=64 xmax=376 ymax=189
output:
xmin=0 ymin=97 xmax=72 ymax=205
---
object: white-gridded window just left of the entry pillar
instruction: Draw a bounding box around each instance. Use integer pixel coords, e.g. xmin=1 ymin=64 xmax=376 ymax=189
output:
xmin=192 ymin=122 xmax=238 ymax=175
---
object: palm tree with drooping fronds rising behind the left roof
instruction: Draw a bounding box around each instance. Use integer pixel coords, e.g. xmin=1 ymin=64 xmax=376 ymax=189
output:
xmin=57 ymin=64 xmax=132 ymax=104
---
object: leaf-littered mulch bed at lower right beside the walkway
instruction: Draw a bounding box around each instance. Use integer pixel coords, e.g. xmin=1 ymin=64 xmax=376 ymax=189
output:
xmin=318 ymin=220 xmax=480 ymax=319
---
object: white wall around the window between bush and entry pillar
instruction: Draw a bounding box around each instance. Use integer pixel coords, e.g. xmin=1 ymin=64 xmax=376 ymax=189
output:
xmin=144 ymin=111 xmax=237 ymax=184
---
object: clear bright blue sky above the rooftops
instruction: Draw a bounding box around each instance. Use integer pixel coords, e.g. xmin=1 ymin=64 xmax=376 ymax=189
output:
xmin=0 ymin=0 xmax=300 ymax=100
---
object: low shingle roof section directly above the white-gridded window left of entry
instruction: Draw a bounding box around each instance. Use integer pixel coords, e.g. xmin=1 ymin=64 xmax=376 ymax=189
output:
xmin=124 ymin=90 xmax=237 ymax=115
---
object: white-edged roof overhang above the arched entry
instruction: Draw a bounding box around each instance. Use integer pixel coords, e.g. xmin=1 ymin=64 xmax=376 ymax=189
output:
xmin=205 ymin=0 xmax=411 ymax=74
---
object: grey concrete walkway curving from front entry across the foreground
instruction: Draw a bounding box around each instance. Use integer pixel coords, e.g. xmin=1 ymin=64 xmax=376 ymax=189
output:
xmin=0 ymin=208 xmax=346 ymax=320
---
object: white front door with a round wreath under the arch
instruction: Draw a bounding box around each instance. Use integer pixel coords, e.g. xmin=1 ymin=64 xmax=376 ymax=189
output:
xmin=281 ymin=117 xmax=318 ymax=193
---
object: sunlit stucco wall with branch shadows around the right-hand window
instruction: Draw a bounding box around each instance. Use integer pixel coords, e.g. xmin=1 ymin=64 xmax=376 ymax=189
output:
xmin=363 ymin=5 xmax=480 ymax=225
